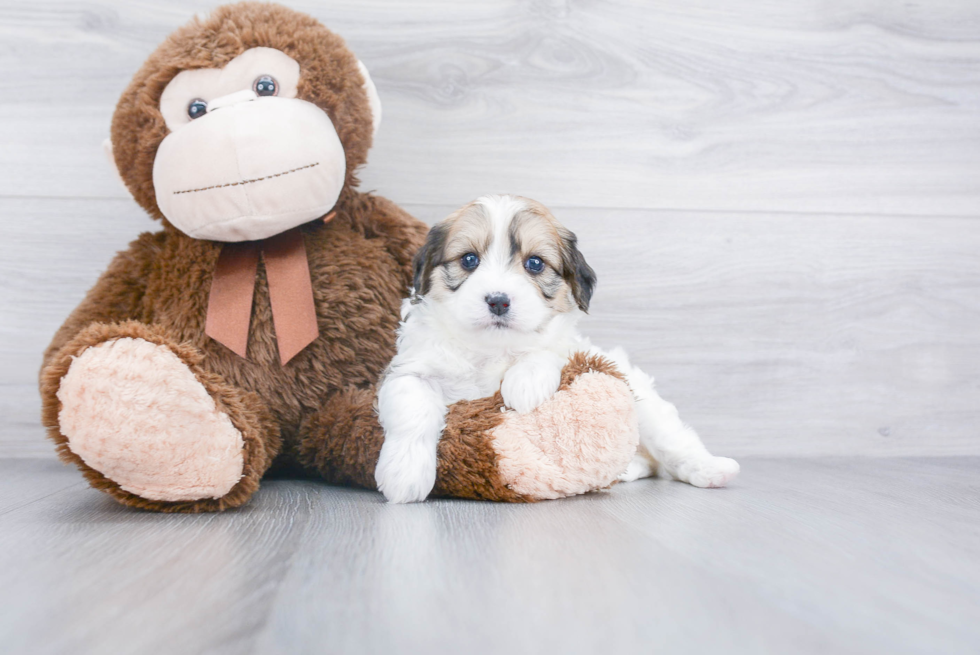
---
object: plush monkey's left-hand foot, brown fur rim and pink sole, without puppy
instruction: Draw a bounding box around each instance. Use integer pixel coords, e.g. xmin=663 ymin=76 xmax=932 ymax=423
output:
xmin=41 ymin=321 xmax=279 ymax=512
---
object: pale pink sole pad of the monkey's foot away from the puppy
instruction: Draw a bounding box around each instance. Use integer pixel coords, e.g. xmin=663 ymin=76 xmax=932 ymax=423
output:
xmin=58 ymin=337 xmax=244 ymax=501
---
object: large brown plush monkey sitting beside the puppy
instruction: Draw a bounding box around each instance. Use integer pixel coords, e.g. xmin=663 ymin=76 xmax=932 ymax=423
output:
xmin=40 ymin=3 xmax=636 ymax=512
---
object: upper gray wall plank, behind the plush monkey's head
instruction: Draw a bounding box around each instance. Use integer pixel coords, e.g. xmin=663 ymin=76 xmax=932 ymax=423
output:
xmin=0 ymin=0 xmax=980 ymax=216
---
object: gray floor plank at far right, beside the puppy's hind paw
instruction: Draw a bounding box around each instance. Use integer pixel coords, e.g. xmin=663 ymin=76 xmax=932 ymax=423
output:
xmin=603 ymin=458 xmax=980 ymax=653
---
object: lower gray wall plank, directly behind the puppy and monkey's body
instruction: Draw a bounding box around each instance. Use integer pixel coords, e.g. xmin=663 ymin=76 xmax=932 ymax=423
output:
xmin=0 ymin=199 xmax=980 ymax=456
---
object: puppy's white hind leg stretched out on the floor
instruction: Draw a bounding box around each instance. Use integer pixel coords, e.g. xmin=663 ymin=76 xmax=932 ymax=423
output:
xmin=602 ymin=348 xmax=739 ymax=487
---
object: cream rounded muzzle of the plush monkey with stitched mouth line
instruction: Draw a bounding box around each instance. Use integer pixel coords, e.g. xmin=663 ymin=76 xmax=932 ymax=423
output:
xmin=153 ymin=93 xmax=347 ymax=241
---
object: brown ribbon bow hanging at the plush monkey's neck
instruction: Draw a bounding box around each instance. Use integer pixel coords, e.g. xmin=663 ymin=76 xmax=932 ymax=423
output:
xmin=204 ymin=222 xmax=333 ymax=366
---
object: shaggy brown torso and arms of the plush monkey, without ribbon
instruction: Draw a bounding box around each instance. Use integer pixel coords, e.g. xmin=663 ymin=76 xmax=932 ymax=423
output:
xmin=42 ymin=193 xmax=427 ymax=509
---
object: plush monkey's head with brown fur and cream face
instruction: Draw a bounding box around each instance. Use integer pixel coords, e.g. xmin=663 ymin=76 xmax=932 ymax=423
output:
xmin=108 ymin=2 xmax=381 ymax=241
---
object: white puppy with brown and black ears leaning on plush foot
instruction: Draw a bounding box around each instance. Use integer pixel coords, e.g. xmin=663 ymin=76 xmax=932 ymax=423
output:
xmin=375 ymin=196 xmax=739 ymax=503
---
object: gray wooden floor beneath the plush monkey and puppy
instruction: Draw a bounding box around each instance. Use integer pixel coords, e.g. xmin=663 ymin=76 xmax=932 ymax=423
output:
xmin=0 ymin=458 xmax=980 ymax=655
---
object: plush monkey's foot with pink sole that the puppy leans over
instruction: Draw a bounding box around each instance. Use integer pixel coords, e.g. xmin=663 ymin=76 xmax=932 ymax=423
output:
xmin=433 ymin=353 xmax=639 ymax=502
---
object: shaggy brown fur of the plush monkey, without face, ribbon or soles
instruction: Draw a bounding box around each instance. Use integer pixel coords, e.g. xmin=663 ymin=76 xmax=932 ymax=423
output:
xmin=40 ymin=3 xmax=636 ymax=512
